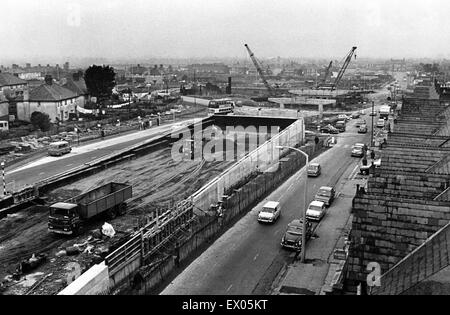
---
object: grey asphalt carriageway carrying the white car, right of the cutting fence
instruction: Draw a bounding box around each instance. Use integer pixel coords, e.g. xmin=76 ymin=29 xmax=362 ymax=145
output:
xmin=161 ymin=115 xmax=370 ymax=295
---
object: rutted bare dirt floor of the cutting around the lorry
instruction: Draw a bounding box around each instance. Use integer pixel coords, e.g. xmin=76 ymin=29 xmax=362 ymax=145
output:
xmin=0 ymin=135 xmax=251 ymax=295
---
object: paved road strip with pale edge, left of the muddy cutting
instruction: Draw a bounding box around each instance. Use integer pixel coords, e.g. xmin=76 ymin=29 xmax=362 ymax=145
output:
xmin=6 ymin=119 xmax=199 ymax=190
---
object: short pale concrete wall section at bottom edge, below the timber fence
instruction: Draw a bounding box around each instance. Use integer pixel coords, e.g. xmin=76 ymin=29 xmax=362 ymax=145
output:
xmin=58 ymin=262 xmax=109 ymax=295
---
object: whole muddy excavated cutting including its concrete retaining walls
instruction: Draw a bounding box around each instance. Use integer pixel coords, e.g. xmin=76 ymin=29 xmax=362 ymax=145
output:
xmin=0 ymin=116 xmax=311 ymax=294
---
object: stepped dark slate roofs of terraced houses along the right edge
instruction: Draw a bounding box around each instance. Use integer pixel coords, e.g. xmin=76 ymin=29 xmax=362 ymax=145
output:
xmin=347 ymin=98 xmax=450 ymax=294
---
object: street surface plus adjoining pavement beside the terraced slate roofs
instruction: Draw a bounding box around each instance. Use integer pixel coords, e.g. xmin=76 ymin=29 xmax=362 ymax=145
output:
xmin=161 ymin=112 xmax=370 ymax=295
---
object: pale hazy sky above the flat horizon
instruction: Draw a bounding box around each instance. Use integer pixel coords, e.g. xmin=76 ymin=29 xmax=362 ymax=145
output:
xmin=0 ymin=0 xmax=450 ymax=62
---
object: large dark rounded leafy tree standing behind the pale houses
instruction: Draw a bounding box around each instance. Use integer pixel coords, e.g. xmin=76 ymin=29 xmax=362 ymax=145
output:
xmin=84 ymin=65 xmax=116 ymax=101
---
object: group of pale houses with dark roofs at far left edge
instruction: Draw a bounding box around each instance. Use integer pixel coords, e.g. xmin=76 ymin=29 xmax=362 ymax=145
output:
xmin=0 ymin=73 xmax=88 ymax=126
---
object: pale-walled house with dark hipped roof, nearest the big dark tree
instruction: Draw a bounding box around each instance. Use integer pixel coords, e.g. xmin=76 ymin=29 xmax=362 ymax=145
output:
xmin=17 ymin=76 xmax=79 ymax=122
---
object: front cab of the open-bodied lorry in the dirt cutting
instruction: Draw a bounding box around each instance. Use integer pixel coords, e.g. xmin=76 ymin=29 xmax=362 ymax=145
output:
xmin=48 ymin=202 xmax=81 ymax=235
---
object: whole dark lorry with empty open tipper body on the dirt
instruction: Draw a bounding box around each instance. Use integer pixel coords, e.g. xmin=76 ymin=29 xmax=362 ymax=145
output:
xmin=48 ymin=182 xmax=132 ymax=235
